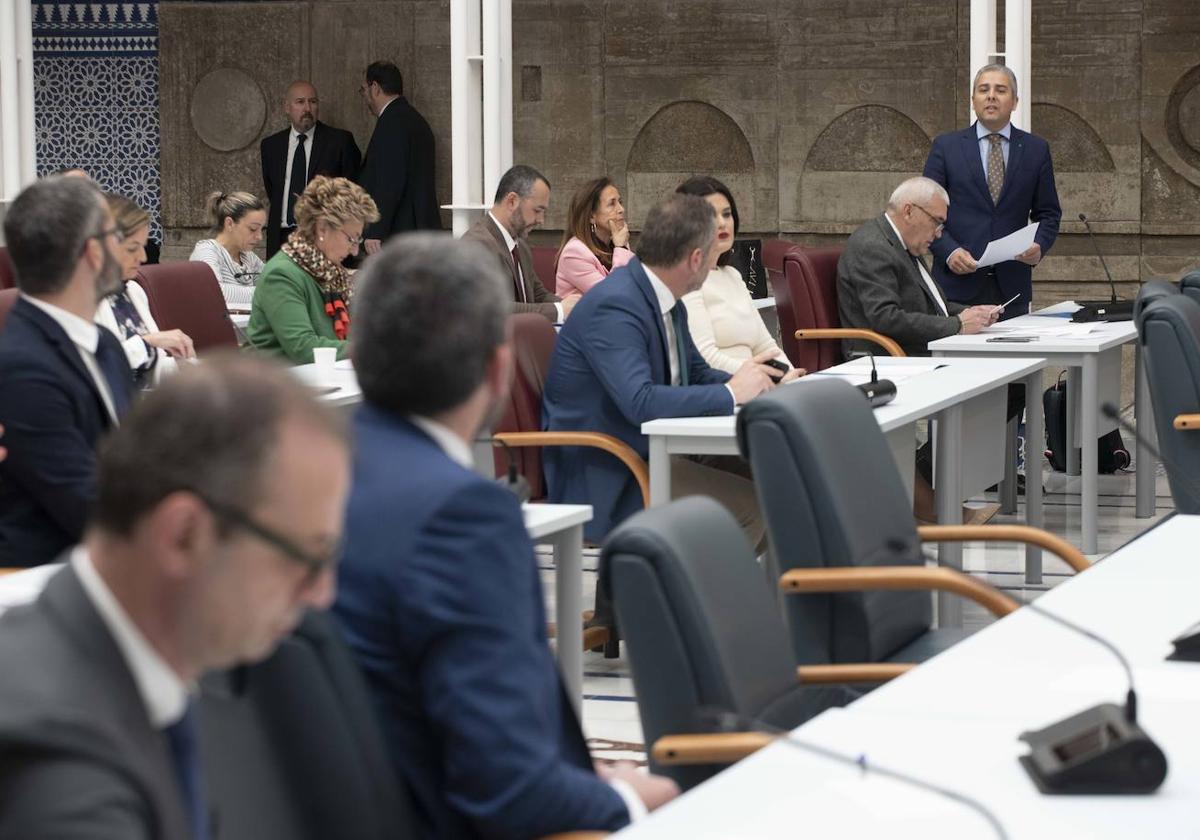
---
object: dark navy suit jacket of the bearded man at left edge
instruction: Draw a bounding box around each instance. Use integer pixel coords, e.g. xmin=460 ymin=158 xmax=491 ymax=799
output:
xmin=0 ymin=299 xmax=133 ymax=566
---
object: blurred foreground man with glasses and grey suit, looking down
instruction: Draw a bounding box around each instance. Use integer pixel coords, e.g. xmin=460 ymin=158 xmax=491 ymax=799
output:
xmin=0 ymin=356 xmax=349 ymax=840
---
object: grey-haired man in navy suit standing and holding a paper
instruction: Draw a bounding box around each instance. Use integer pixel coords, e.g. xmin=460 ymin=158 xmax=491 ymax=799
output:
xmin=925 ymin=65 xmax=1062 ymax=318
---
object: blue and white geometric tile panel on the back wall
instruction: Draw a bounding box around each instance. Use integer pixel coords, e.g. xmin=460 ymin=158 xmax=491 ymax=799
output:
xmin=32 ymin=0 xmax=162 ymax=241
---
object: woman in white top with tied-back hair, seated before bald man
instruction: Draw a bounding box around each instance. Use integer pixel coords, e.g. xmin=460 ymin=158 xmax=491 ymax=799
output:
xmin=191 ymin=192 xmax=266 ymax=310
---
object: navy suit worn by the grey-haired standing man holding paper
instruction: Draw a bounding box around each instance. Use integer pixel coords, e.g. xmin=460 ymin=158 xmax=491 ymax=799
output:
xmin=925 ymin=124 xmax=1062 ymax=309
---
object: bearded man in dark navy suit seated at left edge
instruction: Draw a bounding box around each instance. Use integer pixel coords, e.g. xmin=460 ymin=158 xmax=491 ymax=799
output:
xmin=0 ymin=175 xmax=133 ymax=566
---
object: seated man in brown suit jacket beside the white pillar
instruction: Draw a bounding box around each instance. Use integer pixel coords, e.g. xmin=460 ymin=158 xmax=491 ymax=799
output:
xmin=462 ymin=163 xmax=580 ymax=324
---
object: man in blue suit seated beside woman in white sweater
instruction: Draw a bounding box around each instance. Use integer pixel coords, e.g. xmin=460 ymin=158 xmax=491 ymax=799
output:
xmin=542 ymin=193 xmax=799 ymax=551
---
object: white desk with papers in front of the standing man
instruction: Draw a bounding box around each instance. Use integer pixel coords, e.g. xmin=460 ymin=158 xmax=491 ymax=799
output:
xmin=929 ymin=301 xmax=1154 ymax=554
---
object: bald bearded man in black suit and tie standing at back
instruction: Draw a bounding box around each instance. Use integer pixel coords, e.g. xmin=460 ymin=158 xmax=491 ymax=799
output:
xmin=259 ymin=79 xmax=361 ymax=259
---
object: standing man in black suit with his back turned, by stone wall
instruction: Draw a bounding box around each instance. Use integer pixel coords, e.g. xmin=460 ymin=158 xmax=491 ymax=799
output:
xmin=358 ymin=61 xmax=442 ymax=254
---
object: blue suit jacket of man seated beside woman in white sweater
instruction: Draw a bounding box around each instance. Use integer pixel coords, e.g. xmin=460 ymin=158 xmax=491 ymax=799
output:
xmin=542 ymin=258 xmax=733 ymax=540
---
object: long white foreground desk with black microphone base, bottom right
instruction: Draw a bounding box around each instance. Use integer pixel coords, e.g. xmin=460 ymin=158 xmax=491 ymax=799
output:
xmin=620 ymin=516 xmax=1200 ymax=840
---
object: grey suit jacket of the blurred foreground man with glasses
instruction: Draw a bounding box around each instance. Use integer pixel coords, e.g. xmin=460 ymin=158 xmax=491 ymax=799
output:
xmin=0 ymin=566 xmax=191 ymax=840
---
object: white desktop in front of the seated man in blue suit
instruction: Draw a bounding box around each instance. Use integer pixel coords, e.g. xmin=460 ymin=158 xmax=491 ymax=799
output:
xmin=642 ymin=356 xmax=1045 ymax=437
